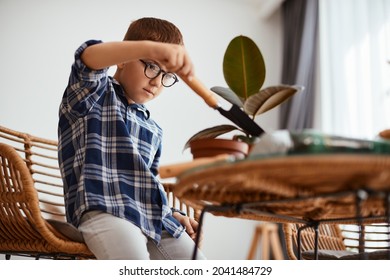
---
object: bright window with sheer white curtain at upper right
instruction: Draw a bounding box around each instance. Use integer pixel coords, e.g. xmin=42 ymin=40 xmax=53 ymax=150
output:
xmin=320 ymin=0 xmax=390 ymax=138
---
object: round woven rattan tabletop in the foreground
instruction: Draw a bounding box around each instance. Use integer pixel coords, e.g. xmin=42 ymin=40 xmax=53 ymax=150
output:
xmin=174 ymin=154 xmax=390 ymax=223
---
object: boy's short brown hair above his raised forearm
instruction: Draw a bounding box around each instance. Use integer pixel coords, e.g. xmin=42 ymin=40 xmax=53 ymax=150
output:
xmin=123 ymin=17 xmax=183 ymax=45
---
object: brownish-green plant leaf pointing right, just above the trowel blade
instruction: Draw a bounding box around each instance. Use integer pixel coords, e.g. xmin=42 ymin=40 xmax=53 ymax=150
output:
xmin=244 ymin=85 xmax=303 ymax=116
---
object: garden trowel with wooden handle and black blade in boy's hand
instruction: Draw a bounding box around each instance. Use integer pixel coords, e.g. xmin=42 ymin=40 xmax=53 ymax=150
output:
xmin=181 ymin=77 xmax=264 ymax=136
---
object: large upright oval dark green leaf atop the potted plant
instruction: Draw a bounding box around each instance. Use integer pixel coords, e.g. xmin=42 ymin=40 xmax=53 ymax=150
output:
xmin=223 ymin=36 xmax=266 ymax=100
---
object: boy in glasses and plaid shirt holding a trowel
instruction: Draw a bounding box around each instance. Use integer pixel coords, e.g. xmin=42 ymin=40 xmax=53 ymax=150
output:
xmin=58 ymin=18 xmax=204 ymax=259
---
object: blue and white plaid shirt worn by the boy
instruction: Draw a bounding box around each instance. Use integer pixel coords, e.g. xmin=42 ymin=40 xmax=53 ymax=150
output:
xmin=58 ymin=41 xmax=184 ymax=242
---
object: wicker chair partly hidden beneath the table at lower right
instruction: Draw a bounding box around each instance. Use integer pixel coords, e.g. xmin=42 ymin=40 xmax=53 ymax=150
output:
xmin=283 ymin=224 xmax=390 ymax=260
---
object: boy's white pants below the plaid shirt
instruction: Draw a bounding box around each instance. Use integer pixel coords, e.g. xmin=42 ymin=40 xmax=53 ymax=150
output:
xmin=79 ymin=211 xmax=205 ymax=260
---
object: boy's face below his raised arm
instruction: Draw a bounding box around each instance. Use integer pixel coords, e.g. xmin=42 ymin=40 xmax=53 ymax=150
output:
xmin=115 ymin=60 xmax=164 ymax=104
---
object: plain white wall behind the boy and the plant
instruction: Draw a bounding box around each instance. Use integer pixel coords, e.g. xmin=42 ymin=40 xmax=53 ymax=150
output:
xmin=0 ymin=0 xmax=282 ymax=259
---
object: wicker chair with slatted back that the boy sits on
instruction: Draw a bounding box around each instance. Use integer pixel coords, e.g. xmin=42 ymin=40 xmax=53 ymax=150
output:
xmin=0 ymin=126 xmax=199 ymax=259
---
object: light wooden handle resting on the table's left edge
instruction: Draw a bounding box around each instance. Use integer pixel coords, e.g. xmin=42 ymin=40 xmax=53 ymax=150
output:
xmin=158 ymin=154 xmax=234 ymax=179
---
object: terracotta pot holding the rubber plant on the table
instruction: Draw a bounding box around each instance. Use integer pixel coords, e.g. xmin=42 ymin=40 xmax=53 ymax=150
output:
xmin=190 ymin=138 xmax=249 ymax=158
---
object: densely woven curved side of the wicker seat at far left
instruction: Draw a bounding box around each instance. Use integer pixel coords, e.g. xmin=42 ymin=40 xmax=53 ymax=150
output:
xmin=0 ymin=143 xmax=94 ymax=258
